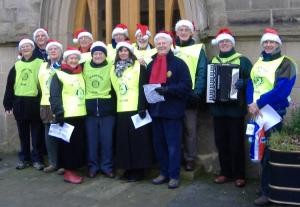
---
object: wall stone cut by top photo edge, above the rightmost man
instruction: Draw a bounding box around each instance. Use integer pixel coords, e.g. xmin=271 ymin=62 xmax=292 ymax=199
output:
xmin=252 ymin=0 xmax=289 ymax=9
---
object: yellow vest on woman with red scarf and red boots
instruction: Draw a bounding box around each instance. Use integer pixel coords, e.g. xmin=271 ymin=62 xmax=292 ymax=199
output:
xmin=56 ymin=71 xmax=86 ymax=118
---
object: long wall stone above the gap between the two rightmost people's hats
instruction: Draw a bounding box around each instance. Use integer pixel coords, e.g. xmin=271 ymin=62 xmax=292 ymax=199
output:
xmin=226 ymin=10 xmax=270 ymax=25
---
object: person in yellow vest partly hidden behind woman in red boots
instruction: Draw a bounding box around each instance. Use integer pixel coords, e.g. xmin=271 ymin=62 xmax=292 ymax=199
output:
xmin=39 ymin=40 xmax=63 ymax=172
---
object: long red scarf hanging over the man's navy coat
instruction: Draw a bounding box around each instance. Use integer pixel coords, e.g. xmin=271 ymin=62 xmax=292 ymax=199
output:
xmin=149 ymin=55 xmax=167 ymax=84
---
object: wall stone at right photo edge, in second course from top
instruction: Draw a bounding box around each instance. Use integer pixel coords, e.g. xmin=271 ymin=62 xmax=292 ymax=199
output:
xmin=273 ymin=8 xmax=300 ymax=25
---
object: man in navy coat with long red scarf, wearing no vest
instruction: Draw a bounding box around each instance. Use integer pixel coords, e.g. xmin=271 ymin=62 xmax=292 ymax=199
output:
xmin=147 ymin=32 xmax=192 ymax=189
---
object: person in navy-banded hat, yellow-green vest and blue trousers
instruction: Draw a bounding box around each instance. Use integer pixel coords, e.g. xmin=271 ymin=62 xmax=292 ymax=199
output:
xmin=83 ymin=41 xmax=116 ymax=178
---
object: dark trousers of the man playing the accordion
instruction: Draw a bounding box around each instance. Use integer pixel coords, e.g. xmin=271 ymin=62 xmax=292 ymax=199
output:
xmin=214 ymin=117 xmax=245 ymax=179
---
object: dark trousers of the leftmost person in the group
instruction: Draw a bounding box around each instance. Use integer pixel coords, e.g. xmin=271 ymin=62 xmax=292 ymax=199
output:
xmin=17 ymin=120 xmax=42 ymax=162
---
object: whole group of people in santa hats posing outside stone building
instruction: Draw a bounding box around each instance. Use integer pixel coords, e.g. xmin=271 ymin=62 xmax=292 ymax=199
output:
xmin=3 ymin=20 xmax=296 ymax=205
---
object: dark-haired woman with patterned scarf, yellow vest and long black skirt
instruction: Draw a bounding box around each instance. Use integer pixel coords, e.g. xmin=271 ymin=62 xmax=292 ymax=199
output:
xmin=111 ymin=42 xmax=153 ymax=182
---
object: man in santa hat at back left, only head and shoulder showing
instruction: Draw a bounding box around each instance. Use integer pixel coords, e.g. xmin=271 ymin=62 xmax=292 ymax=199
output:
xmin=33 ymin=28 xmax=49 ymax=61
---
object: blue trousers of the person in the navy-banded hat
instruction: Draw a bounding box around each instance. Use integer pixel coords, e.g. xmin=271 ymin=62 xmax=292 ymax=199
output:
xmin=85 ymin=116 xmax=115 ymax=173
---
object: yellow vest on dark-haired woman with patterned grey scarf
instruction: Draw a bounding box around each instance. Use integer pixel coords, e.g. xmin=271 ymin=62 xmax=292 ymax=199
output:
xmin=111 ymin=61 xmax=140 ymax=112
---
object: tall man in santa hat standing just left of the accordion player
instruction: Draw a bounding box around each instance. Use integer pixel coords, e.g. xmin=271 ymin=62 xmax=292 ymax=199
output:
xmin=175 ymin=19 xmax=207 ymax=171
